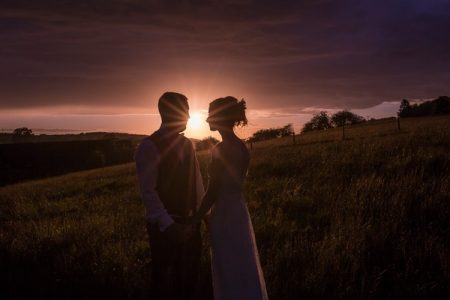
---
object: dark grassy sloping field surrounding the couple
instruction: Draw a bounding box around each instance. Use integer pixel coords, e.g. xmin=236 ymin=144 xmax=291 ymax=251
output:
xmin=0 ymin=117 xmax=450 ymax=299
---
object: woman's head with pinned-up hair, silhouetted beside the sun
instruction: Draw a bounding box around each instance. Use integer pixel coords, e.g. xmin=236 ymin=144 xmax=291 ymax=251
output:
xmin=206 ymin=96 xmax=247 ymax=130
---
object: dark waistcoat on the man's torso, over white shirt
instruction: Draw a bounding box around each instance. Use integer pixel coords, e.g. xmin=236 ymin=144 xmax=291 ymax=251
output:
xmin=148 ymin=131 xmax=197 ymax=217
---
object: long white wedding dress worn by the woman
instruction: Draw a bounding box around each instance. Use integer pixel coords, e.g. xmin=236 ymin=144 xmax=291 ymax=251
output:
xmin=209 ymin=141 xmax=268 ymax=300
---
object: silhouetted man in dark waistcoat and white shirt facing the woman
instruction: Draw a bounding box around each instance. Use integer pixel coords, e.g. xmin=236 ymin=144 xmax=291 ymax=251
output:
xmin=135 ymin=92 xmax=204 ymax=299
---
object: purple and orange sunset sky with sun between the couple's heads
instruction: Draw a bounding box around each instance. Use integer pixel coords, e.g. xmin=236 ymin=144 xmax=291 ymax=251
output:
xmin=0 ymin=0 xmax=450 ymax=138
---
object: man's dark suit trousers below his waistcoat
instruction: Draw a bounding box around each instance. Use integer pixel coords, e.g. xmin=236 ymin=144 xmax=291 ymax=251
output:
xmin=147 ymin=223 xmax=202 ymax=300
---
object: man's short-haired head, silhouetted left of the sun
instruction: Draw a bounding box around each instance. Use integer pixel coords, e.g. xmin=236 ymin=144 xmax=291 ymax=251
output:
xmin=158 ymin=92 xmax=189 ymax=132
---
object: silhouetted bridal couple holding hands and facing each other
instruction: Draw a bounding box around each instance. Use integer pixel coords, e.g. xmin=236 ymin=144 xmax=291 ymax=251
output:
xmin=136 ymin=92 xmax=268 ymax=300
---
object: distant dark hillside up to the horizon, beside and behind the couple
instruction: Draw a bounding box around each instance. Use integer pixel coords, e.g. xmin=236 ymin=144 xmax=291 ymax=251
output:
xmin=0 ymin=132 xmax=200 ymax=186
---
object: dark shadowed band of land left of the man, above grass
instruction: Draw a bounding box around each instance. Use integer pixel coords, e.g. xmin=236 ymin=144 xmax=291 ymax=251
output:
xmin=0 ymin=139 xmax=136 ymax=186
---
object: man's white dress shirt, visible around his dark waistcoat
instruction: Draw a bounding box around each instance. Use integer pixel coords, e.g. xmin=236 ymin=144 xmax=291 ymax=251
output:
xmin=135 ymin=128 xmax=205 ymax=231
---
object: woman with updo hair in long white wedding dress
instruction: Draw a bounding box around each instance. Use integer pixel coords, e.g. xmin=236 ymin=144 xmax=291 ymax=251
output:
xmin=193 ymin=96 xmax=268 ymax=300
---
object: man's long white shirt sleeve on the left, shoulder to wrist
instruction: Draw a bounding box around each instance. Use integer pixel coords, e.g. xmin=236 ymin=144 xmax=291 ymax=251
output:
xmin=135 ymin=139 xmax=174 ymax=231
